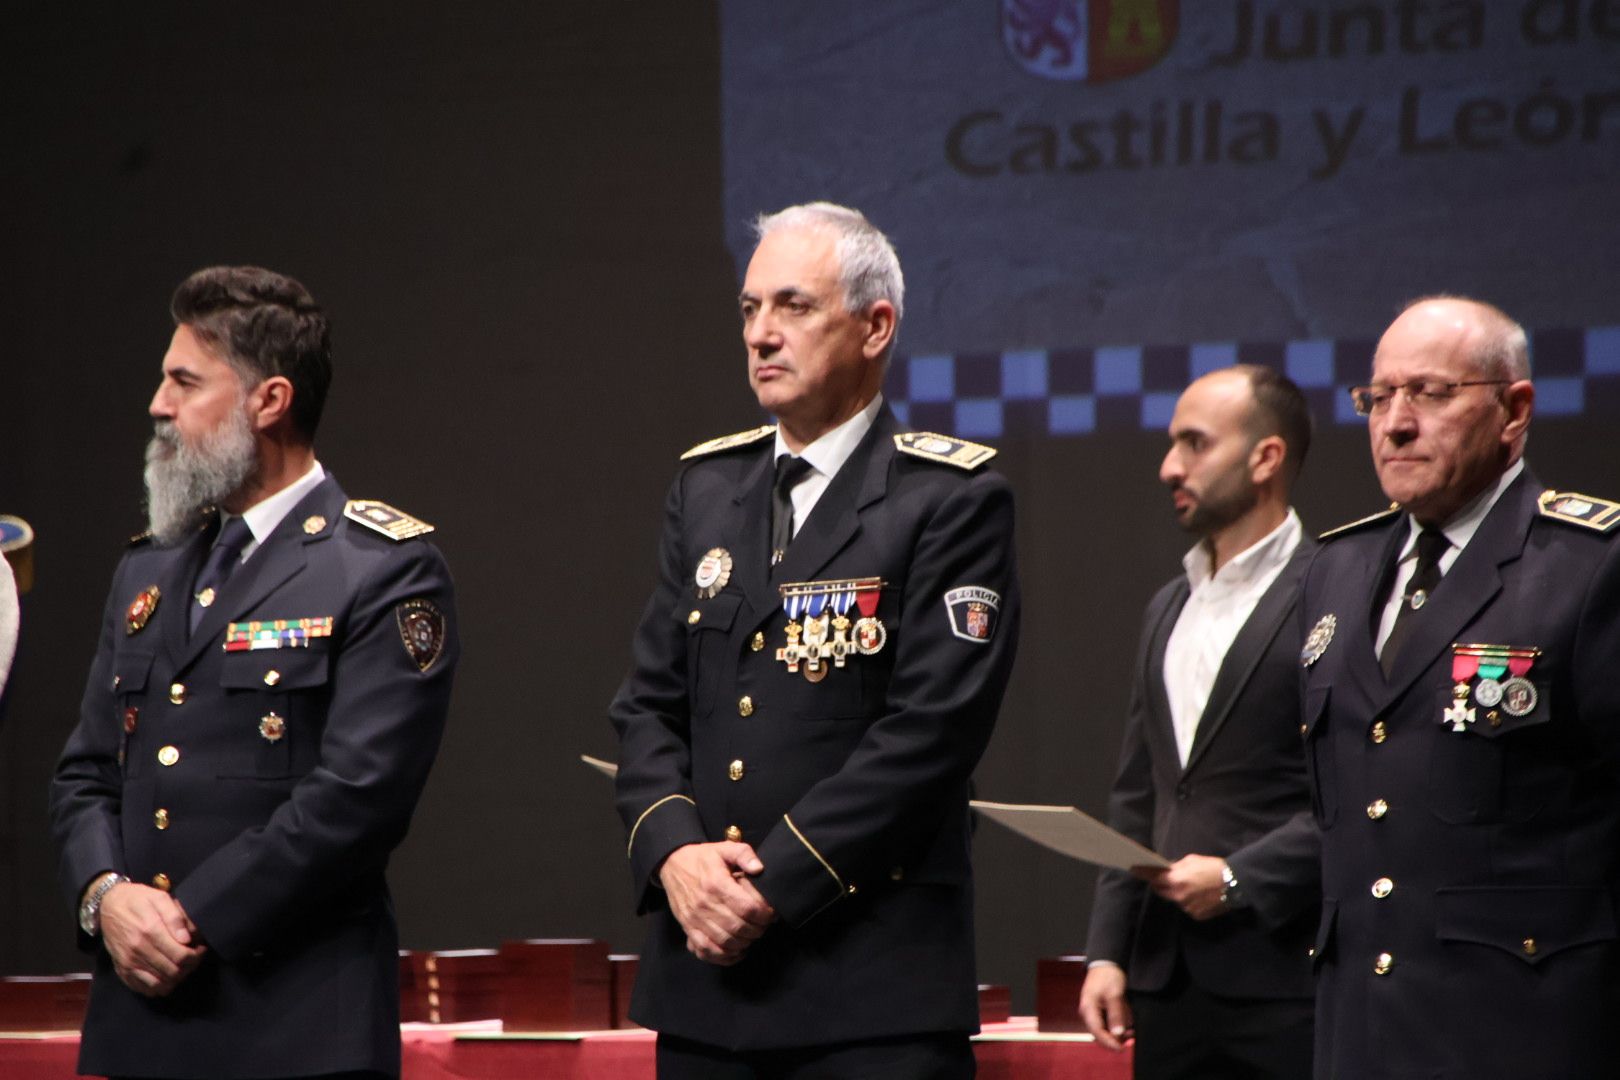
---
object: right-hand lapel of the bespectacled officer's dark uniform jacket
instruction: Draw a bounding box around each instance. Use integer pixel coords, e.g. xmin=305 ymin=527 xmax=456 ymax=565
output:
xmin=1380 ymin=470 xmax=1541 ymax=711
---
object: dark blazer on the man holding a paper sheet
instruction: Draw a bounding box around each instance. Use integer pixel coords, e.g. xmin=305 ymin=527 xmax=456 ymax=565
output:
xmin=1085 ymin=538 xmax=1320 ymax=997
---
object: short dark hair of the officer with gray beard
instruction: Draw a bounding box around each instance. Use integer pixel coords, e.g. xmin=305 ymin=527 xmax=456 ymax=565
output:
xmin=168 ymin=266 xmax=332 ymax=440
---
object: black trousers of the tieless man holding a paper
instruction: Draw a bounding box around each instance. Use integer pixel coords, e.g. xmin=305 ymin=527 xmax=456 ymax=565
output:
xmin=1131 ymin=963 xmax=1315 ymax=1080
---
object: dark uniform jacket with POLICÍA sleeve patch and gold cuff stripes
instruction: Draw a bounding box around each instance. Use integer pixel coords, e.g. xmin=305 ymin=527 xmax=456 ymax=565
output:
xmin=611 ymin=410 xmax=1019 ymax=1049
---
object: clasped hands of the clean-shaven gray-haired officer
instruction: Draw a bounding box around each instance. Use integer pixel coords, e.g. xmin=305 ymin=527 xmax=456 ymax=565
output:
xmin=658 ymin=840 xmax=776 ymax=967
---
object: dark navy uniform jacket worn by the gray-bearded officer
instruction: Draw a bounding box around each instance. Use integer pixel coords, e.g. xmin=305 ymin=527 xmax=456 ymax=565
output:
xmin=50 ymin=478 xmax=458 ymax=1077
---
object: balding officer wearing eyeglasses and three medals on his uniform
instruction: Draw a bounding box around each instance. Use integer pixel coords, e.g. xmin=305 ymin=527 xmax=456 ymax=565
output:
xmin=1301 ymin=296 xmax=1620 ymax=1080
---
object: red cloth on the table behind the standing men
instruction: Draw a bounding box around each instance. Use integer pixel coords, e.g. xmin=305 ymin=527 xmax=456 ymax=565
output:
xmin=0 ymin=1017 xmax=1131 ymax=1080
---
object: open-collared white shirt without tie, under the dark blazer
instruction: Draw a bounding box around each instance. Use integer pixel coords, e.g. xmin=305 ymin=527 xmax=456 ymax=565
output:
xmin=1165 ymin=508 xmax=1304 ymax=766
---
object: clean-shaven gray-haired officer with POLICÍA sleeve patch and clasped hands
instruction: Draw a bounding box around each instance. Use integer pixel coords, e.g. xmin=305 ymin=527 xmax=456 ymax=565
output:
xmin=611 ymin=202 xmax=1019 ymax=1080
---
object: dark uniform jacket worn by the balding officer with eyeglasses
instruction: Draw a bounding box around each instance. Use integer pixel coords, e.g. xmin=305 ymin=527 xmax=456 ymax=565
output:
xmin=1301 ymin=471 xmax=1620 ymax=1080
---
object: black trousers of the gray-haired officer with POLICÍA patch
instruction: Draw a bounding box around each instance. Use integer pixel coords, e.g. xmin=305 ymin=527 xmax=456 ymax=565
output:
xmin=658 ymin=1031 xmax=978 ymax=1080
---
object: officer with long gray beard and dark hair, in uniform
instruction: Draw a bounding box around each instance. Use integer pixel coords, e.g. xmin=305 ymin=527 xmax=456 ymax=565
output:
xmin=50 ymin=267 xmax=458 ymax=1077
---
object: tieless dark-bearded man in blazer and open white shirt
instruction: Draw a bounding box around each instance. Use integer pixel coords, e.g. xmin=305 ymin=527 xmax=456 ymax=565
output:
xmin=1081 ymin=364 xmax=1320 ymax=1080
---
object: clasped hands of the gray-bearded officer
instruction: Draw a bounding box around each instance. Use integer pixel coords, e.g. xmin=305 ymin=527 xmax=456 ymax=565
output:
xmin=100 ymin=881 xmax=207 ymax=997
